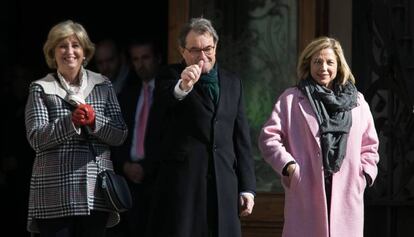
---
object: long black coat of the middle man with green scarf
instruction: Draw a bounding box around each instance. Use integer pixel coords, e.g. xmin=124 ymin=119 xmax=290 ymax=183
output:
xmin=146 ymin=65 xmax=256 ymax=237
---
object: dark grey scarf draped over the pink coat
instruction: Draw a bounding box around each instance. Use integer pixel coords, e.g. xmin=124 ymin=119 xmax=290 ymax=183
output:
xmin=298 ymin=78 xmax=358 ymax=176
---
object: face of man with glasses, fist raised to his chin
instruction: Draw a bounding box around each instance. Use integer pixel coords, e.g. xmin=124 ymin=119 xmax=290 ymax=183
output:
xmin=180 ymin=31 xmax=217 ymax=73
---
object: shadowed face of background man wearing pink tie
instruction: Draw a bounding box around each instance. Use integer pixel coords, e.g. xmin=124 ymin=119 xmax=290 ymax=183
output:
xmin=130 ymin=45 xmax=160 ymax=81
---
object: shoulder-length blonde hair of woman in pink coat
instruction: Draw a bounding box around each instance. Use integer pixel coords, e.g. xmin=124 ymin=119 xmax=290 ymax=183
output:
xmin=296 ymin=36 xmax=355 ymax=85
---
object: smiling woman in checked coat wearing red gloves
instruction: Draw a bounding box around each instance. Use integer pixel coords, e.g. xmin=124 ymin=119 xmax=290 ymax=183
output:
xmin=25 ymin=20 xmax=127 ymax=237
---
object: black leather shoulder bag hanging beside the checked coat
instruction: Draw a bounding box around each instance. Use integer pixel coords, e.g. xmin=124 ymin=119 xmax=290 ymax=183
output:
xmin=98 ymin=170 xmax=132 ymax=212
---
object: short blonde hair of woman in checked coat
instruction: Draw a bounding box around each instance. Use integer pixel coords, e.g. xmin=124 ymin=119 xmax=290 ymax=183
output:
xmin=43 ymin=20 xmax=95 ymax=69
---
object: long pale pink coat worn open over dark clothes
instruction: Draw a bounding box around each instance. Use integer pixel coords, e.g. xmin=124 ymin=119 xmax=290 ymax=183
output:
xmin=259 ymin=88 xmax=379 ymax=237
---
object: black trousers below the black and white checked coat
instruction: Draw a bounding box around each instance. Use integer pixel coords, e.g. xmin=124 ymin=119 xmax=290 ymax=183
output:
xmin=36 ymin=211 xmax=108 ymax=237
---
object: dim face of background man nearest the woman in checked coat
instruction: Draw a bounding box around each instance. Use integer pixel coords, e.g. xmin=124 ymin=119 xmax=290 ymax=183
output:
xmin=95 ymin=45 xmax=121 ymax=80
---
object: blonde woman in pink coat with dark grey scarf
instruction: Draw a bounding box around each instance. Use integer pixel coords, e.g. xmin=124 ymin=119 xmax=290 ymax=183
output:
xmin=259 ymin=37 xmax=379 ymax=237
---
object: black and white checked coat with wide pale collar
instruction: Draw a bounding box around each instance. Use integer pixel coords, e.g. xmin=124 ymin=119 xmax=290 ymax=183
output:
xmin=25 ymin=70 xmax=127 ymax=232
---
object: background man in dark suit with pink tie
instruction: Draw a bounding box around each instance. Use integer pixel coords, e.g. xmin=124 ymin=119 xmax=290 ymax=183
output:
xmin=114 ymin=38 xmax=161 ymax=236
